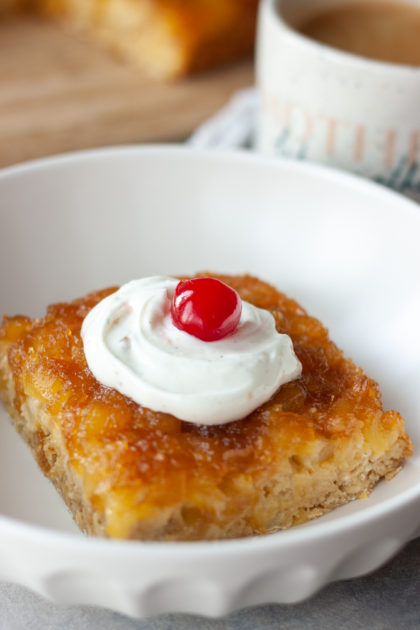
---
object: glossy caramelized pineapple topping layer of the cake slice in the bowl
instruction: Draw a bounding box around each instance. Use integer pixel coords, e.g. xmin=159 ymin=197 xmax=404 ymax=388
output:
xmin=0 ymin=276 xmax=411 ymax=538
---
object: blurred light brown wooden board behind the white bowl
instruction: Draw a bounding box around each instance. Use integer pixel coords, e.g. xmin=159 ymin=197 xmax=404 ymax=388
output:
xmin=0 ymin=17 xmax=253 ymax=166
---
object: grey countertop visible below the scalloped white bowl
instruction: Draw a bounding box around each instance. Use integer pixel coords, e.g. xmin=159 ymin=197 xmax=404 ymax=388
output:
xmin=0 ymin=538 xmax=420 ymax=630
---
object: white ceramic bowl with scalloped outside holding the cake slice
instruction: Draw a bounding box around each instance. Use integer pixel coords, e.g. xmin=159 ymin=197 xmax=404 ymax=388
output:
xmin=0 ymin=147 xmax=420 ymax=617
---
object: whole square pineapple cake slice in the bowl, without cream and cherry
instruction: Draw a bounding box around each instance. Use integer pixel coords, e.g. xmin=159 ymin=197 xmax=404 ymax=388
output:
xmin=0 ymin=276 xmax=411 ymax=540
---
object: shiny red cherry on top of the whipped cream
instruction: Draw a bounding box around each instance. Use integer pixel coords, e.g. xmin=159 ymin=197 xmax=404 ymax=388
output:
xmin=171 ymin=278 xmax=242 ymax=341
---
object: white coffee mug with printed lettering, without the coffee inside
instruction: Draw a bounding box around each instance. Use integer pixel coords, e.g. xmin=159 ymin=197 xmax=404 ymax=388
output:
xmin=256 ymin=0 xmax=420 ymax=196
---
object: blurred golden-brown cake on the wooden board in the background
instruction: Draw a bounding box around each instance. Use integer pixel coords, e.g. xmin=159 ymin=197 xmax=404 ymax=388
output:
xmin=0 ymin=0 xmax=258 ymax=79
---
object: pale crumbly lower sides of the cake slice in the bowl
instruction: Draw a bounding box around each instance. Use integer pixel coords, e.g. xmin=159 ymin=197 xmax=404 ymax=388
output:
xmin=0 ymin=354 xmax=410 ymax=540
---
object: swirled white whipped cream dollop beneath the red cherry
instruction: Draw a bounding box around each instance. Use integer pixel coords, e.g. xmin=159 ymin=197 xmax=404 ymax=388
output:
xmin=82 ymin=276 xmax=302 ymax=425
